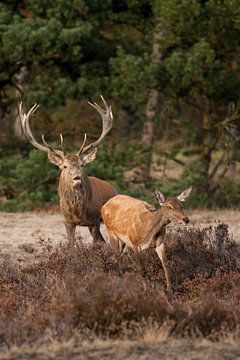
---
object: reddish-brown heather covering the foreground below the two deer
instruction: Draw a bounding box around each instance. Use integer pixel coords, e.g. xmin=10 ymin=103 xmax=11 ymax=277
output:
xmin=0 ymin=224 xmax=240 ymax=352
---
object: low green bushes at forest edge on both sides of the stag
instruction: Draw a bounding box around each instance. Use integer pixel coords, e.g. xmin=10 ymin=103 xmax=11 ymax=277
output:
xmin=0 ymin=143 xmax=240 ymax=211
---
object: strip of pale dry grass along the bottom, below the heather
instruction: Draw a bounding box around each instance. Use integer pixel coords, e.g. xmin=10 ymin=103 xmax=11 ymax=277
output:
xmin=1 ymin=339 xmax=240 ymax=360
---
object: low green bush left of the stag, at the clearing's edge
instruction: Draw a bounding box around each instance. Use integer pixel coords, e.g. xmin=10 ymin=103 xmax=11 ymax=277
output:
xmin=0 ymin=150 xmax=58 ymax=211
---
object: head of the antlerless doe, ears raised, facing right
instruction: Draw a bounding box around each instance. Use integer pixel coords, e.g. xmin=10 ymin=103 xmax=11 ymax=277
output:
xmin=154 ymin=186 xmax=192 ymax=224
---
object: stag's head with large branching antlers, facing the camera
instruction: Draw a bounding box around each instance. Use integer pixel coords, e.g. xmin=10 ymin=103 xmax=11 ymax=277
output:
xmin=19 ymin=96 xmax=113 ymax=187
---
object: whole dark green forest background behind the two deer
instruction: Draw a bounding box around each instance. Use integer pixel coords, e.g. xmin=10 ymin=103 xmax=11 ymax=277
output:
xmin=0 ymin=0 xmax=240 ymax=211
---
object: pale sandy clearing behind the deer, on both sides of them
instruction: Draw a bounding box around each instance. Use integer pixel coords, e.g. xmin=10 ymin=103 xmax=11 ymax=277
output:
xmin=0 ymin=210 xmax=240 ymax=261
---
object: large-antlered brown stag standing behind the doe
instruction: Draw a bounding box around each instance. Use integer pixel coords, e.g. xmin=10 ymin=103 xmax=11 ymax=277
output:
xmin=19 ymin=96 xmax=117 ymax=243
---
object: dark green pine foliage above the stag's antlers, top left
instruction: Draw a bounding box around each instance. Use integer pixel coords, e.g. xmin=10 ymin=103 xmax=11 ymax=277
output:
xmin=0 ymin=0 xmax=115 ymax=107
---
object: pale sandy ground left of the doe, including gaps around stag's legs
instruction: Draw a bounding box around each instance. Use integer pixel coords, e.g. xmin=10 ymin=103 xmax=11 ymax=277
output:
xmin=0 ymin=211 xmax=106 ymax=262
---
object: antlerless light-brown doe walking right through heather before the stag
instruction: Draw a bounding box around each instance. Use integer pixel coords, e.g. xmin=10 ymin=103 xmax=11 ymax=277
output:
xmin=101 ymin=187 xmax=192 ymax=292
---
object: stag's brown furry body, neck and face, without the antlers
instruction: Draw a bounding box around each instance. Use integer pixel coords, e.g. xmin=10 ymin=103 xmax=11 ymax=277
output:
xmin=58 ymin=155 xmax=117 ymax=241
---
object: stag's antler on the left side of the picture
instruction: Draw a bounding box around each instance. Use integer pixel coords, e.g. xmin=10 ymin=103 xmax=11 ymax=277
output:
xmin=18 ymin=102 xmax=64 ymax=157
